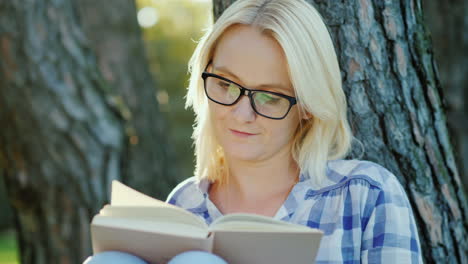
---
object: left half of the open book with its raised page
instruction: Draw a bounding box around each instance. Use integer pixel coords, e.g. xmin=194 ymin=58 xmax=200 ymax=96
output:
xmin=91 ymin=181 xmax=213 ymax=264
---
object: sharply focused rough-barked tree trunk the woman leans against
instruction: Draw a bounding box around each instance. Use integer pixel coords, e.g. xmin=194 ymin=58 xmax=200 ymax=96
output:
xmin=213 ymin=0 xmax=468 ymax=263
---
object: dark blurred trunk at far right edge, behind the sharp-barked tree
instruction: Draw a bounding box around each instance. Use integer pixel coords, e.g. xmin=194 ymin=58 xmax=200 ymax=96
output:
xmin=423 ymin=0 xmax=468 ymax=194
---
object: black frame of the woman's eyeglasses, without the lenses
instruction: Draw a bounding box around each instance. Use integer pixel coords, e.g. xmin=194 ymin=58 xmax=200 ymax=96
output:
xmin=202 ymin=64 xmax=297 ymax=120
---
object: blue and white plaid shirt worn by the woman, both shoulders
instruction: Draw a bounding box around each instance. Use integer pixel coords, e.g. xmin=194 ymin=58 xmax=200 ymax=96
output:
xmin=167 ymin=160 xmax=422 ymax=263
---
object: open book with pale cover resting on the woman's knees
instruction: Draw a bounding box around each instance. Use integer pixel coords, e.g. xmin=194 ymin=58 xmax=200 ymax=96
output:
xmin=91 ymin=181 xmax=322 ymax=264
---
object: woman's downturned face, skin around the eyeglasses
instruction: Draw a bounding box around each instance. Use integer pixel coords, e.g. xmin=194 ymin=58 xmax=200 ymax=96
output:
xmin=208 ymin=25 xmax=299 ymax=162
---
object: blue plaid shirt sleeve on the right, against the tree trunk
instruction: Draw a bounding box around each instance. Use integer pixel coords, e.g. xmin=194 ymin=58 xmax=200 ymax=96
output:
xmin=361 ymin=171 xmax=422 ymax=263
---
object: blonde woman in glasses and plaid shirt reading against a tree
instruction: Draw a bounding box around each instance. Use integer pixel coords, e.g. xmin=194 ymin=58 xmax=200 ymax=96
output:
xmin=86 ymin=0 xmax=422 ymax=263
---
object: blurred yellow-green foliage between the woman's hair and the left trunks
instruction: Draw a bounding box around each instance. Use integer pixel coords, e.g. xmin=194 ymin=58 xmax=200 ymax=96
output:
xmin=137 ymin=0 xmax=212 ymax=177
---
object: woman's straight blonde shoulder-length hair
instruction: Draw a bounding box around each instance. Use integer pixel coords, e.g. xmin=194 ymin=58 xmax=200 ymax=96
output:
xmin=186 ymin=0 xmax=353 ymax=185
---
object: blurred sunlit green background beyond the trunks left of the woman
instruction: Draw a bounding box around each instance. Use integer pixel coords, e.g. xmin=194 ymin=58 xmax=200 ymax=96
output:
xmin=0 ymin=0 xmax=213 ymax=264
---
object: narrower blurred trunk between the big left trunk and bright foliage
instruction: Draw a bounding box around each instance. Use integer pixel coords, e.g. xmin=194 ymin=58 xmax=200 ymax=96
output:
xmin=76 ymin=0 xmax=180 ymax=196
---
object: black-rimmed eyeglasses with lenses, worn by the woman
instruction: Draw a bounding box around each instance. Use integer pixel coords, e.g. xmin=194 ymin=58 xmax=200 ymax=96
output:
xmin=202 ymin=68 xmax=297 ymax=120
